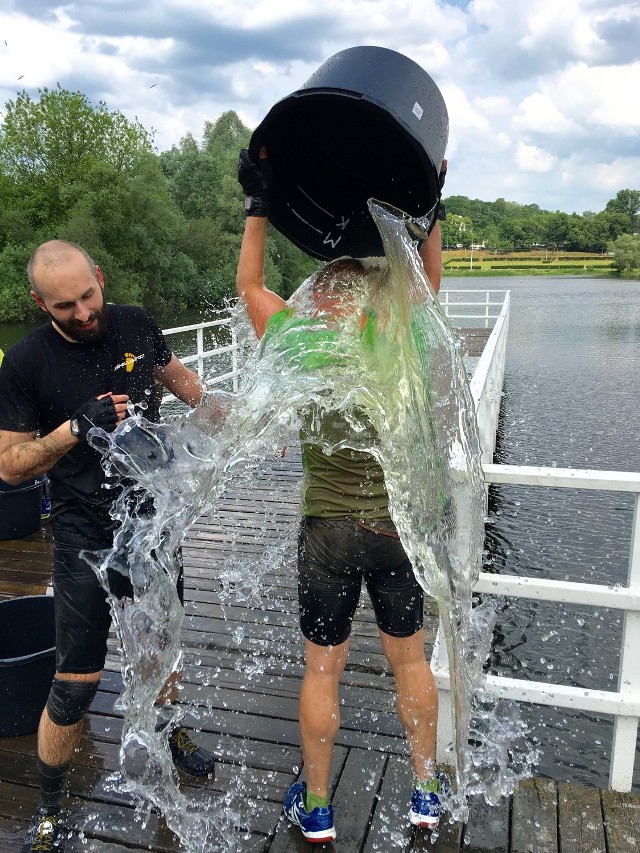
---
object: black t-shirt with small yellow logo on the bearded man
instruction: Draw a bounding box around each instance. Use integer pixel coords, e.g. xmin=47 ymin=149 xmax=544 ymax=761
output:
xmin=0 ymin=305 xmax=171 ymax=548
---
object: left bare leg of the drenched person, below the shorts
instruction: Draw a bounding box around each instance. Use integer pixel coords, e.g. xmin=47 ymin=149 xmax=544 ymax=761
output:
xmin=300 ymin=639 xmax=349 ymax=797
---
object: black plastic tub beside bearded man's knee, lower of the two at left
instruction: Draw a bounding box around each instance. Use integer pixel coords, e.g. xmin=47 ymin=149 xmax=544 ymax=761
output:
xmin=0 ymin=595 xmax=56 ymax=737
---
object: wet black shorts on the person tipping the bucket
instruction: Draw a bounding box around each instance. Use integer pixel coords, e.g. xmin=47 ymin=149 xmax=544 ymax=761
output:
xmin=298 ymin=516 xmax=424 ymax=646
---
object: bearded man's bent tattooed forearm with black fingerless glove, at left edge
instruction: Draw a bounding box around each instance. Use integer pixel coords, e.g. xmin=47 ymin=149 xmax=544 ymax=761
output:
xmin=0 ymin=394 xmax=129 ymax=486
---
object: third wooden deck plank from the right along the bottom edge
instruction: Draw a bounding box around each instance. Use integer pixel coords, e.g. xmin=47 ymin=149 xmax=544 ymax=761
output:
xmin=511 ymin=779 xmax=558 ymax=853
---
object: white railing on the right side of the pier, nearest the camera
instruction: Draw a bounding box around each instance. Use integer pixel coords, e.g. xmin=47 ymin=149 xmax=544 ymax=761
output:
xmin=431 ymin=312 xmax=640 ymax=791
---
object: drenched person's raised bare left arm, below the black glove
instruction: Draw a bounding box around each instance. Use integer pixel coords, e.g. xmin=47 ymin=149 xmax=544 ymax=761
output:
xmin=236 ymin=216 xmax=287 ymax=338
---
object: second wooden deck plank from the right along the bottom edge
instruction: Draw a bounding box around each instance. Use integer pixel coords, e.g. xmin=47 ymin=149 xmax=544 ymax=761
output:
xmin=558 ymin=782 xmax=608 ymax=853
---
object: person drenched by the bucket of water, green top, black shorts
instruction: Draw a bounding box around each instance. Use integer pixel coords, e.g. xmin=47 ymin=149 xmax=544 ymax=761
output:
xmin=237 ymin=150 xmax=446 ymax=842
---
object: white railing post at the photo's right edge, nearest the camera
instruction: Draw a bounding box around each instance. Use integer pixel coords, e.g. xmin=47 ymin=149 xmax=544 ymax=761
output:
xmin=609 ymin=494 xmax=640 ymax=791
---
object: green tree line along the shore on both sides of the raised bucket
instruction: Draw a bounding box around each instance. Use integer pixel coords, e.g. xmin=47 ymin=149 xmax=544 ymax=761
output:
xmin=0 ymin=86 xmax=640 ymax=322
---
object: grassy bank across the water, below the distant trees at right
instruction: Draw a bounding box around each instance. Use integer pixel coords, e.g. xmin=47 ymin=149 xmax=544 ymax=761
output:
xmin=442 ymin=249 xmax=616 ymax=278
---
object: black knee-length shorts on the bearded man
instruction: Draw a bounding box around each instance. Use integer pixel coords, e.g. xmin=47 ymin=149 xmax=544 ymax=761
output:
xmin=53 ymin=543 xmax=184 ymax=673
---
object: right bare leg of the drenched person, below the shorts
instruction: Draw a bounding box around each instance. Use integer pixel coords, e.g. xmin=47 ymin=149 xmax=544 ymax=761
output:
xmin=380 ymin=630 xmax=438 ymax=781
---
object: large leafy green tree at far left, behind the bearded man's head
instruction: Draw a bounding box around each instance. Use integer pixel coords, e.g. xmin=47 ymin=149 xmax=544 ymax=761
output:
xmin=0 ymin=87 xmax=199 ymax=320
